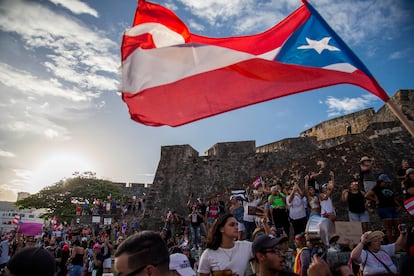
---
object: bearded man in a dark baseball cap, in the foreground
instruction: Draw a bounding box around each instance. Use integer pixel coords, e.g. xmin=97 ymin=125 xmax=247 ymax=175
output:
xmin=252 ymin=234 xmax=297 ymax=276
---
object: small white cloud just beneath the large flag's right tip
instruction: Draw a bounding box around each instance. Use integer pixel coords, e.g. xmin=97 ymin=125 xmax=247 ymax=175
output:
xmin=325 ymin=94 xmax=378 ymax=117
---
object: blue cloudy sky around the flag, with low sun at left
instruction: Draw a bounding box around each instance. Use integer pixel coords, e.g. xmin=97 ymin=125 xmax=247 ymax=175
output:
xmin=0 ymin=0 xmax=414 ymax=201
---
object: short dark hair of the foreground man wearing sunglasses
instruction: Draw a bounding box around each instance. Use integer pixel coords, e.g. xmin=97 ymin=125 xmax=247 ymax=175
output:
xmin=115 ymin=231 xmax=170 ymax=272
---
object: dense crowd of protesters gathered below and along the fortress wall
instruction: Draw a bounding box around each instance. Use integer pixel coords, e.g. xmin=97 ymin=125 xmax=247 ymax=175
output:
xmin=0 ymin=156 xmax=414 ymax=276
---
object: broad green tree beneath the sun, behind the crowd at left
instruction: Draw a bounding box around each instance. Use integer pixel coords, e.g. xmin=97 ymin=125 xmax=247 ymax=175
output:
xmin=16 ymin=175 xmax=122 ymax=221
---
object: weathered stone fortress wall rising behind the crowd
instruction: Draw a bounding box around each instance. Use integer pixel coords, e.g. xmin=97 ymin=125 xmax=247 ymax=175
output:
xmin=143 ymin=90 xmax=414 ymax=229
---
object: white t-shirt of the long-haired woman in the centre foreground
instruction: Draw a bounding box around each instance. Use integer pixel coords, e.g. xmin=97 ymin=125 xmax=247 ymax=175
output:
xmin=197 ymin=241 xmax=253 ymax=276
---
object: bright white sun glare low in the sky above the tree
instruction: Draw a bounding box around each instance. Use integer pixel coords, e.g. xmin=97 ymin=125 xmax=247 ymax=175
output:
xmin=27 ymin=153 xmax=95 ymax=193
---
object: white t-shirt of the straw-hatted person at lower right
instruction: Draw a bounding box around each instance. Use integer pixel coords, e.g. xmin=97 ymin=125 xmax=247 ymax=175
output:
xmin=360 ymin=243 xmax=397 ymax=275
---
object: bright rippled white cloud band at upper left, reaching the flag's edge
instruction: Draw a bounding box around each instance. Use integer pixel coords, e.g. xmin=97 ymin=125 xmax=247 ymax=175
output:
xmin=0 ymin=0 xmax=119 ymax=93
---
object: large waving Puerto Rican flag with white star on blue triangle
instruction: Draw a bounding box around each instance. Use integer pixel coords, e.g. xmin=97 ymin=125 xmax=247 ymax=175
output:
xmin=121 ymin=0 xmax=389 ymax=126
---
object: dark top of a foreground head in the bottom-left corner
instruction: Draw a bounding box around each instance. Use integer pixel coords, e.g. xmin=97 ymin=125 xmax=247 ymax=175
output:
xmin=7 ymin=247 xmax=56 ymax=276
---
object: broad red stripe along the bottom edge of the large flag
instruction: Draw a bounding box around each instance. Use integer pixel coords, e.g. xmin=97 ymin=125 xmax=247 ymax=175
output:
xmin=122 ymin=59 xmax=378 ymax=126
